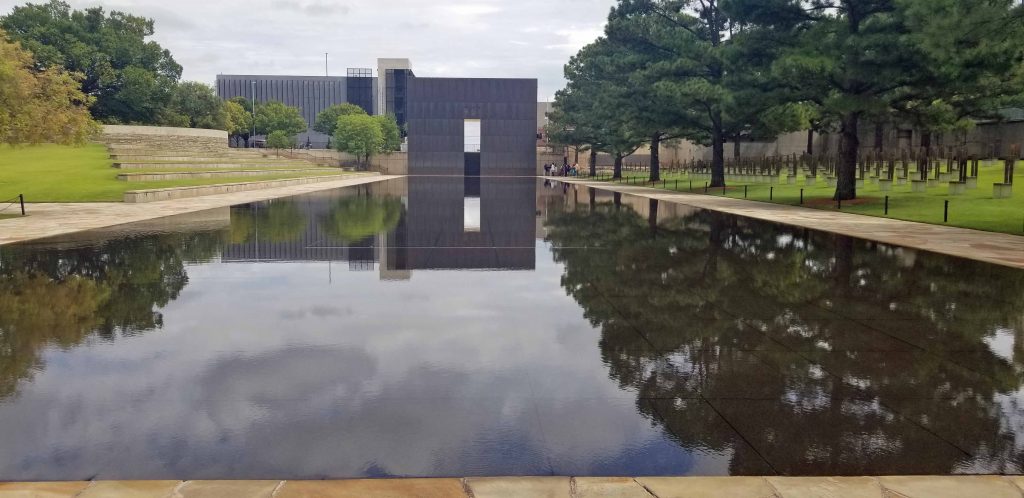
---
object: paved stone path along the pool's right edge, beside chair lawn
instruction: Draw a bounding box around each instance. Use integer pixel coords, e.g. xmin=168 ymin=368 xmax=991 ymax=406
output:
xmin=558 ymin=178 xmax=1024 ymax=268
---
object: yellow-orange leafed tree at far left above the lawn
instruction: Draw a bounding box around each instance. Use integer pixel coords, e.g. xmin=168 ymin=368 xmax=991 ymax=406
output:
xmin=0 ymin=31 xmax=98 ymax=144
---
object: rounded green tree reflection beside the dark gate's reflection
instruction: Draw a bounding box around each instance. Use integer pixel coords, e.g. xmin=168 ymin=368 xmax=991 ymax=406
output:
xmin=319 ymin=196 xmax=402 ymax=243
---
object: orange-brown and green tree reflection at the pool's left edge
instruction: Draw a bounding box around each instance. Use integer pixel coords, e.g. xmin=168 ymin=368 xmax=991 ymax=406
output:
xmin=0 ymin=232 xmax=223 ymax=398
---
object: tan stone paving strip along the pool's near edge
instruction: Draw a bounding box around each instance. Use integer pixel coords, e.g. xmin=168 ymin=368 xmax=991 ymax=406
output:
xmin=0 ymin=475 xmax=1024 ymax=498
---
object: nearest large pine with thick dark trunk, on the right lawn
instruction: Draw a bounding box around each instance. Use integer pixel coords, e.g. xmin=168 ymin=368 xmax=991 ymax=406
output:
xmin=734 ymin=0 xmax=1024 ymax=200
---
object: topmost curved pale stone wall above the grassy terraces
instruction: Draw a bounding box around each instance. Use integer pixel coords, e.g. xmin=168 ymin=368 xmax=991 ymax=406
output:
xmin=99 ymin=125 xmax=227 ymax=155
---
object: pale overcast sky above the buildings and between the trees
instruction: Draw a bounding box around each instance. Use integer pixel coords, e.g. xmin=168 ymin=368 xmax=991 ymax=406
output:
xmin=0 ymin=0 xmax=614 ymax=99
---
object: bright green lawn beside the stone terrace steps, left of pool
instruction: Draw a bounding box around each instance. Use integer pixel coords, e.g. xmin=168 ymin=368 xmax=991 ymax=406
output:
xmin=0 ymin=143 xmax=341 ymax=202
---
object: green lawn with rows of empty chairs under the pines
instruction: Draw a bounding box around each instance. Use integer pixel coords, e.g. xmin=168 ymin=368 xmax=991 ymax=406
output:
xmin=593 ymin=162 xmax=1024 ymax=235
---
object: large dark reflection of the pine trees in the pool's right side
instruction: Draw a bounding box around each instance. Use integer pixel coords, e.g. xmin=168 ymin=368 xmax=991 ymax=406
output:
xmin=548 ymin=193 xmax=1024 ymax=473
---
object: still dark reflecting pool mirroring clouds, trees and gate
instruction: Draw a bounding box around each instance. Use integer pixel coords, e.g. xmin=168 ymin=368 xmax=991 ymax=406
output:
xmin=0 ymin=177 xmax=1024 ymax=480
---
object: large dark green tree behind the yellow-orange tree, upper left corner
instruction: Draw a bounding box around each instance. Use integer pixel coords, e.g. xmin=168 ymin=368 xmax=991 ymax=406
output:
xmin=0 ymin=0 xmax=181 ymax=124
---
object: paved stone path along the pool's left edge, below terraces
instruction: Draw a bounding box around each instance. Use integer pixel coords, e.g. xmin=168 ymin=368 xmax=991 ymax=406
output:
xmin=0 ymin=173 xmax=396 ymax=245
